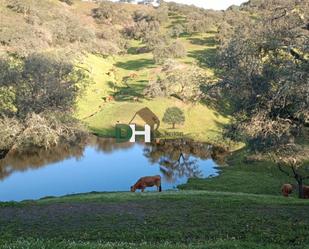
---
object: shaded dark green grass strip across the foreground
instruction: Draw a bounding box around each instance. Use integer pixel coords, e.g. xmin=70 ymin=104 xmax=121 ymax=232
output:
xmin=0 ymin=191 xmax=309 ymax=248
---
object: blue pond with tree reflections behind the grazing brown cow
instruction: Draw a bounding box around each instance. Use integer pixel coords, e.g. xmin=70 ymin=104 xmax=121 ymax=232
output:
xmin=0 ymin=137 xmax=224 ymax=201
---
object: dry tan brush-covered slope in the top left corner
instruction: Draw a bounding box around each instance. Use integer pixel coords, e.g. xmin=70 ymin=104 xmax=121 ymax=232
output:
xmin=0 ymin=0 xmax=122 ymax=58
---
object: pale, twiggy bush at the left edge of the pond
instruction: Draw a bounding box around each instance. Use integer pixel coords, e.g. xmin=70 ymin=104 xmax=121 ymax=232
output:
xmin=0 ymin=112 xmax=86 ymax=151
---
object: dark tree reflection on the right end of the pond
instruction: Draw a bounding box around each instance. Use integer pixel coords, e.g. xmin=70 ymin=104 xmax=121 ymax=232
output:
xmin=144 ymin=139 xmax=223 ymax=181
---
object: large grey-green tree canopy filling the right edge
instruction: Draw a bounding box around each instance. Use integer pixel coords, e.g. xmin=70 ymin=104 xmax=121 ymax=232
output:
xmin=214 ymin=0 xmax=309 ymax=196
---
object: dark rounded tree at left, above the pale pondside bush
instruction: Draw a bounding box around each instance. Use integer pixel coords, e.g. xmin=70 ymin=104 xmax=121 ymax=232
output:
xmin=0 ymin=51 xmax=88 ymax=117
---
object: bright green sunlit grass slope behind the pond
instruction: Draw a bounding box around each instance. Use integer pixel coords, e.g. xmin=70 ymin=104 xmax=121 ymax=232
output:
xmin=76 ymin=30 xmax=229 ymax=142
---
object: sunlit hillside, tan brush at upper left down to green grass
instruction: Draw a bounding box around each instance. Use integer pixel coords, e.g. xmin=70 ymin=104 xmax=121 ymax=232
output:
xmin=0 ymin=0 xmax=229 ymax=142
